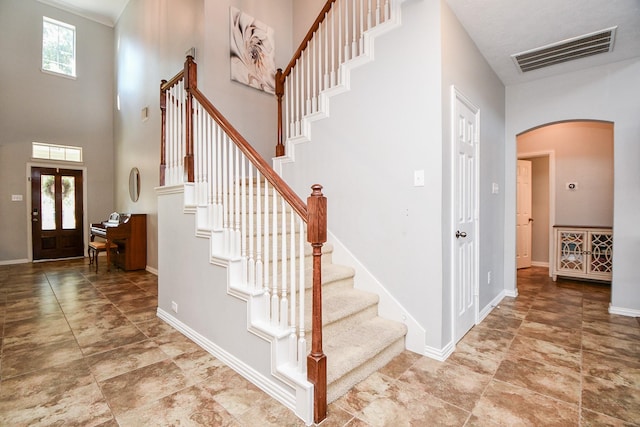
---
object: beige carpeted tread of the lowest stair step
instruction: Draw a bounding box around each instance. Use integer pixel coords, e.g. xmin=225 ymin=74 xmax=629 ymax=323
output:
xmin=323 ymin=317 xmax=407 ymax=387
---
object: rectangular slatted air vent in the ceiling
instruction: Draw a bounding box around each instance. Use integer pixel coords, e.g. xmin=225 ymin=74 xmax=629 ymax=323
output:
xmin=511 ymin=27 xmax=617 ymax=73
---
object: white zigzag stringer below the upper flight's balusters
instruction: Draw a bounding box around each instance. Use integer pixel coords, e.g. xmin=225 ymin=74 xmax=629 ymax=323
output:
xmin=272 ymin=0 xmax=406 ymax=176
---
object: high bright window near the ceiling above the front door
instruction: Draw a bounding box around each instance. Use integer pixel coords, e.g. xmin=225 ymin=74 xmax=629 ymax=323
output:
xmin=42 ymin=16 xmax=76 ymax=77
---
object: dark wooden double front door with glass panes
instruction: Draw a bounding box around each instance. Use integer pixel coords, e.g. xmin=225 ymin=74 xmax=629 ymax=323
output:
xmin=31 ymin=167 xmax=84 ymax=260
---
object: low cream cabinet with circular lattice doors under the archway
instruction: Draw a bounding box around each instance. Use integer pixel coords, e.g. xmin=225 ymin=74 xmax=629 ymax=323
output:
xmin=552 ymin=226 xmax=613 ymax=282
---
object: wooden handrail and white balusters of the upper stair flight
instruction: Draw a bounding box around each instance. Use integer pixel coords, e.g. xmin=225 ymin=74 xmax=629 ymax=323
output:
xmin=276 ymin=0 xmax=393 ymax=157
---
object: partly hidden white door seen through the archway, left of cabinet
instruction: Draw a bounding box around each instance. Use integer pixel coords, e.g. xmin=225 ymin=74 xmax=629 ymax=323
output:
xmin=516 ymin=160 xmax=533 ymax=268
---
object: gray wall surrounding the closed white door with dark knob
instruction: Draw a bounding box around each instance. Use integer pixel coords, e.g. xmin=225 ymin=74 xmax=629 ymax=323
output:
xmin=441 ymin=1 xmax=505 ymax=338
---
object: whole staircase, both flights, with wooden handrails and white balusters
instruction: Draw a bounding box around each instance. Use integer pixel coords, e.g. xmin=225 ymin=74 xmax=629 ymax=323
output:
xmin=158 ymin=0 xmax=407 ymax=424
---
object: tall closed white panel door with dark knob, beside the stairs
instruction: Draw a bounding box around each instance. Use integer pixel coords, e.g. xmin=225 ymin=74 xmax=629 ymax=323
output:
xmin=451 ymin=88 xmax=480 ymax=342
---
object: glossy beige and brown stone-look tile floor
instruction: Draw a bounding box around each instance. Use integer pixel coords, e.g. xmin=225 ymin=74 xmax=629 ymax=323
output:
xmin=0 ymin=260 xmax=640 ymax=427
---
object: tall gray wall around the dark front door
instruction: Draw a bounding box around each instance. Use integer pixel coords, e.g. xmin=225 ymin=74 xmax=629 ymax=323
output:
xmin=0 ymin=0 xmax=115 ymax=263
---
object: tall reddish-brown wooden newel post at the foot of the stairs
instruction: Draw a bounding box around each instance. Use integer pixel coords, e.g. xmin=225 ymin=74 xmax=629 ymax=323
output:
xmin=307 ymin=184 xmax=327 ymax=423
